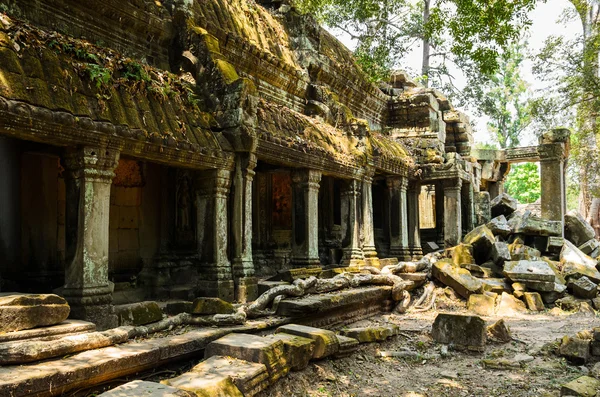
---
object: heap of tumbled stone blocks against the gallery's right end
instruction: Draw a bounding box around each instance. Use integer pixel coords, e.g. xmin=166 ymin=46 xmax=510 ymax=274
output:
xmin=432 ymin=194 xmax=600 ymax=315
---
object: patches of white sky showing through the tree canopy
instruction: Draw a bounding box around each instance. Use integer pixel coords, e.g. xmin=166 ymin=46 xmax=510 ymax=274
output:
xmin=332 ymin=0 xmax=581 ymax=146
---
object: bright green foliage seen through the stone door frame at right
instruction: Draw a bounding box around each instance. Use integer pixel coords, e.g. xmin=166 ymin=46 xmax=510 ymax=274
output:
xmin=504 ymin=163 xmax=541 ymax=204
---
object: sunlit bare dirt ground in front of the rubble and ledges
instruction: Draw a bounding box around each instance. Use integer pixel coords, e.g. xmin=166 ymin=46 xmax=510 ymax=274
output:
xmin=259 ymin=296 xmax=600 ymax=397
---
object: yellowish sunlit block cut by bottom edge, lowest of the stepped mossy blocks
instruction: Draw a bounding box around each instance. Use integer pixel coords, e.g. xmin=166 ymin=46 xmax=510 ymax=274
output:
xmin=161 ymin=372 xmax=244 ymax=397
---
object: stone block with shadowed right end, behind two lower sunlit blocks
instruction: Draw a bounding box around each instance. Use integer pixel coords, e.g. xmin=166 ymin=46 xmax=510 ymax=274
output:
xmin=204 ymin=334 xmax=289 ymax=384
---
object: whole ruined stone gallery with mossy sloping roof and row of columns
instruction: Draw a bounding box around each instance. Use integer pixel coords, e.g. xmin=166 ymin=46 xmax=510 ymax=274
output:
xmin=0 ymin=0 xmax=584 ymax=395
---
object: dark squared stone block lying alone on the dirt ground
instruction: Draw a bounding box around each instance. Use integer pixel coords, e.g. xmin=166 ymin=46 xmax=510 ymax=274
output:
xmin=431 ymin=313 xmax=486 ymax=350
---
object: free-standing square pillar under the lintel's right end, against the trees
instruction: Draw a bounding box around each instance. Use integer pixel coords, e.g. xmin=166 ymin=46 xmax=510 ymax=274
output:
xmin=538 ymin=143 xmax=566 ymax=222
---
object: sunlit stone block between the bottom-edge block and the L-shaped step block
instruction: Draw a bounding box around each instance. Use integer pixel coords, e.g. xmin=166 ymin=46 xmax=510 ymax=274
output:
xmin=188 ymin=356 xmax=269 ymax=397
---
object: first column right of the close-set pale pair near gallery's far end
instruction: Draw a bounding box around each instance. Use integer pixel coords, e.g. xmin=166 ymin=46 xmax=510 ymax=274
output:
xmin=386 ymin=177 xmax=411 ymax=261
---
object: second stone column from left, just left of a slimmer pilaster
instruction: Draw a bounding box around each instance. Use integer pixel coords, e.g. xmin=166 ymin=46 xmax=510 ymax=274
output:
xmin=196 ymin=170 xmax=234 ymax=302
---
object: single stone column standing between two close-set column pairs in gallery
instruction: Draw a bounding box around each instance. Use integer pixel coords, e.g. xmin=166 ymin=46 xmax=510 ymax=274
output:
xmin=292 ymin=170 xmax=321 ymax=267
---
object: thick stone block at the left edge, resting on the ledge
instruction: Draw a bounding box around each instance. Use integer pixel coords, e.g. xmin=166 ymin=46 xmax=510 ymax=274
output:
xmin=0 ymin=292 xmax=70 ymax=333
